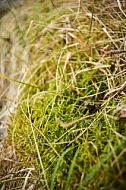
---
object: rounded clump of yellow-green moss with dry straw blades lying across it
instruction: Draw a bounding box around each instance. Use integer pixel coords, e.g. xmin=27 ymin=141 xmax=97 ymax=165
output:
xmin=9 ymin=0 xmax=126 ymax=189
